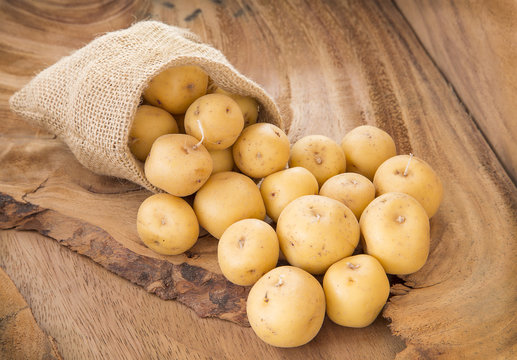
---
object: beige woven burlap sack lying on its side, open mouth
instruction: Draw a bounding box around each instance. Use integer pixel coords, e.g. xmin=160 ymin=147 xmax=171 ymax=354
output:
xmin=9 ymin=21 xmax=283 ymax=191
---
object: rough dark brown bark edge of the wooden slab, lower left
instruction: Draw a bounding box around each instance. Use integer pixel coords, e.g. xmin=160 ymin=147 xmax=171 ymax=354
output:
xmin=0 ymin=194 xmax=249 ymax=326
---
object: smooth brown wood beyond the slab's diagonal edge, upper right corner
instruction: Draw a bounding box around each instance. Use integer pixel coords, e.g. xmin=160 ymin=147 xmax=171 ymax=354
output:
xmin=396 ymin=0 xmax=517 ymax=183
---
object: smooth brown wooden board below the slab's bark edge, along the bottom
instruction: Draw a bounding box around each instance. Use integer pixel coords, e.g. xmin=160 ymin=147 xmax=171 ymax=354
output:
xmin=0 ymin=230 xmax=404 ymax=360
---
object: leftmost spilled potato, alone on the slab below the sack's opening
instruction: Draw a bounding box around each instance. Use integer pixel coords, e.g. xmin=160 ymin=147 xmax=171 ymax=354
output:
xmin=136 ymin=194 xmax=199 ymax=255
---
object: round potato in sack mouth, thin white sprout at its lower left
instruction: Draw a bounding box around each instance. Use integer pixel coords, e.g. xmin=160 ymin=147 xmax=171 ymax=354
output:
xmin=184 ymin=94 xmax=244 ymax=150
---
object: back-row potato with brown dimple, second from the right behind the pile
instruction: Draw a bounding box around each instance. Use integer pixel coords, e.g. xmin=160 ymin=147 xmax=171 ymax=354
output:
xmin=289 ymin=135 xmax=346 ymax=186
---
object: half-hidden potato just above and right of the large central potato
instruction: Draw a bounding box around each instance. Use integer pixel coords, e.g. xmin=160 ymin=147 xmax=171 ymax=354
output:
xmin=320 ymin=173 xmax=375 ymax=220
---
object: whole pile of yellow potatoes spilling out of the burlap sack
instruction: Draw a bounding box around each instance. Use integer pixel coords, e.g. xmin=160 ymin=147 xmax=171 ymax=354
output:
xmin=129 ymin=66 xmax=443 ymax=347
